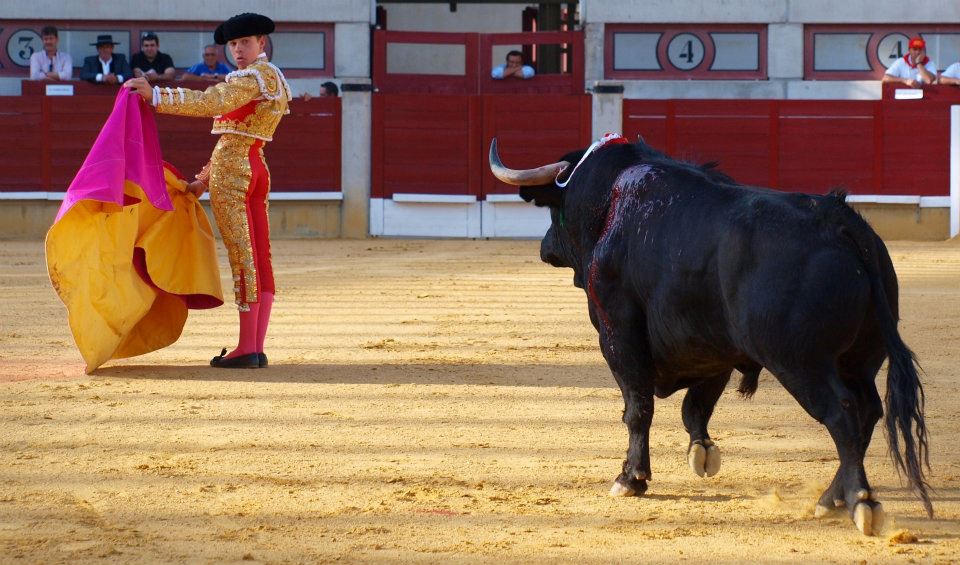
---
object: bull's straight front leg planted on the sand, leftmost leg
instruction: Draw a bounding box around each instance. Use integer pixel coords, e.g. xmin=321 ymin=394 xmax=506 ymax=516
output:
xmin=591 ymin=300 xmax=654 ymax=496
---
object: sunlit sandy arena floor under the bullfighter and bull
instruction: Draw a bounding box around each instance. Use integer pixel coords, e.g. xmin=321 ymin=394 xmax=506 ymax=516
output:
xmin=0 ymin=240 xmax=960 ymax=564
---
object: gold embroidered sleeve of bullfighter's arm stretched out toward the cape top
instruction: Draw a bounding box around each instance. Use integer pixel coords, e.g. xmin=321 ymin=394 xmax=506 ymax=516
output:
xmin=153 ymin=72 xmax=260 ymax=118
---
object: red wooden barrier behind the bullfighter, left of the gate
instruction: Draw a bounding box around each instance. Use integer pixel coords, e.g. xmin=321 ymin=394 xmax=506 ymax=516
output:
xmin=0 ymin=82 xmax=341 ymax=192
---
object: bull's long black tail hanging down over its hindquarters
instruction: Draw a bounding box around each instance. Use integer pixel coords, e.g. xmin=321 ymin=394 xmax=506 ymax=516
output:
xmin=837 ymin=195 xmax=933 ymax=517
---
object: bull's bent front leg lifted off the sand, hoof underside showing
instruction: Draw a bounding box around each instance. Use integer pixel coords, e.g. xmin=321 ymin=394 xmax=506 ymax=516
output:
xmin=683 ymin=371 xmax=731 ymax=477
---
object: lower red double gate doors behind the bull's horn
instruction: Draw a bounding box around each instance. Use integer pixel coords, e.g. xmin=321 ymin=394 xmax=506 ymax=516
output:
xmin=371 ymin=94 xmax=591 ymax=199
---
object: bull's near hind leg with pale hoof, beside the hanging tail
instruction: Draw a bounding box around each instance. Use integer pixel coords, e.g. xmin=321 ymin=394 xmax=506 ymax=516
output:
xmin=775 ymin=366 xmax=883 ymax=535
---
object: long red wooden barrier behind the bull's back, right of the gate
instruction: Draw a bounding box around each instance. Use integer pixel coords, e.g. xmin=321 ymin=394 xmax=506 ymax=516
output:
xmin=623 ymin=85 xmax=960 ymax=196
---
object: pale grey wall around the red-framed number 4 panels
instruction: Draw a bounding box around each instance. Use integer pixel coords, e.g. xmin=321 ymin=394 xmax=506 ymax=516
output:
xmin=580 ymin=0 xmax=960 ymax=100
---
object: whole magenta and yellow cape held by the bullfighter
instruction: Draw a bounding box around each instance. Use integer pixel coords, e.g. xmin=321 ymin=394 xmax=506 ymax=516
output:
xmin=46 ymin=89 xmax=223 ymax=373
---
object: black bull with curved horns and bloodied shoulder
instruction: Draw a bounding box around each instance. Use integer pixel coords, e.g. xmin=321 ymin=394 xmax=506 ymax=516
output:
xmin=490 ymin=140 xmax=933 ymax=535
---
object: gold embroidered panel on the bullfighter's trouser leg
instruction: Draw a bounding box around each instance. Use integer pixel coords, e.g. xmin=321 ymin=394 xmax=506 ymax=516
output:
xmin=210 ymin=135 xmax=262 ymax=312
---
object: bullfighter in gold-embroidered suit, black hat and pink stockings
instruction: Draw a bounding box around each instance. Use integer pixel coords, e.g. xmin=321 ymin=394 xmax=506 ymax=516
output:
xmin=124 ymin=13 xmax=292 ymax=369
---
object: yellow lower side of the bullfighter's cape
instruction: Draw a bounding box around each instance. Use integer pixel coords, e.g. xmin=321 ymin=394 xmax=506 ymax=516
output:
xmin=46 ymin=168 xmax=223 ymax=373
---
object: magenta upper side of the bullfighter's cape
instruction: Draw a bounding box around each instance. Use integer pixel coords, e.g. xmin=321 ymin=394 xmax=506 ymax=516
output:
xmin=54 ymin=88 xmax=173 ymax=223
